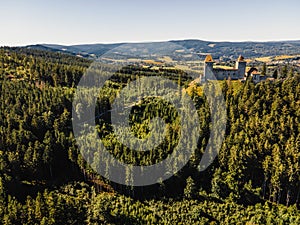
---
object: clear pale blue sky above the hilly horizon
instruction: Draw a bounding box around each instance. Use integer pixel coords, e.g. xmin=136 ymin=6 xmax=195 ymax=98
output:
xmin=0 ymin=0 xmax=300 ymax=46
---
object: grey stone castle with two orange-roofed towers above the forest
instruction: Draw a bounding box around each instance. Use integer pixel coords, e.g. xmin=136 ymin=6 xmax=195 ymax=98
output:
xmin=200 ymin=55 xmax=247 ymax=82
